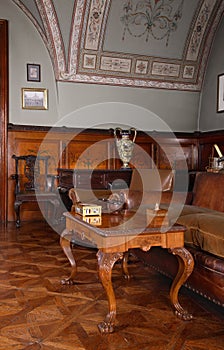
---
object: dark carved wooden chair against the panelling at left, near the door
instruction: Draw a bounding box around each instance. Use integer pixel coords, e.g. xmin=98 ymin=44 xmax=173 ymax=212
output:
xmin=12 ymin=155 xmax=60 ymax=227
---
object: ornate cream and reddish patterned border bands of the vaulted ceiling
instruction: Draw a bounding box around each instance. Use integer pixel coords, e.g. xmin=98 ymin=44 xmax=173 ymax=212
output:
xmin=13 ymin=0 xmax=224 ymax=91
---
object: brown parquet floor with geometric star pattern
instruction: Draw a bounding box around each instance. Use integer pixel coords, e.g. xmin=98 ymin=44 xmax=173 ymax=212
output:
xmin=0 ymin=223 xmax=224 ymax=350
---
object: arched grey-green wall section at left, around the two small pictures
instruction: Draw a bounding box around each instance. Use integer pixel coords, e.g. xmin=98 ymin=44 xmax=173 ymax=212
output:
xmin=0 ymin=0 xmax=58 ymax=126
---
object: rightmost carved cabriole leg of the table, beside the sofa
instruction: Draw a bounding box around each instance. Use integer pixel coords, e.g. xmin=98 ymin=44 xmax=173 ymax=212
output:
xmin=170 ymin=248 xmax=194 ymax=321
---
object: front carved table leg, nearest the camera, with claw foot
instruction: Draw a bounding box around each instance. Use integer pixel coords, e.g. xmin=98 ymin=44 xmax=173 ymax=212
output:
xmin=97 ymin=250 xmax=123 ymax=333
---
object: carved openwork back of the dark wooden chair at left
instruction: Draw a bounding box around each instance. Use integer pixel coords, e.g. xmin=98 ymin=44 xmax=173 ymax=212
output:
xmin=12 ymin=154 xmax=52 ymax=194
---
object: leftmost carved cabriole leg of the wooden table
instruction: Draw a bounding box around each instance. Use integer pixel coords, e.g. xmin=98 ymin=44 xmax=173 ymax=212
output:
xmin=60 ymin=229 xmax=77 ymax=284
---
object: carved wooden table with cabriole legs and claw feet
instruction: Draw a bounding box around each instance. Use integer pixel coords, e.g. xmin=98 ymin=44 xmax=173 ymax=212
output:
xmin=60 ymin=211 xmax=194 ymax=333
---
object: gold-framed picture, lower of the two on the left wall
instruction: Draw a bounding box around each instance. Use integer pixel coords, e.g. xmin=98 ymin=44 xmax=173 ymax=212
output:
xmin=22 ymin=88 xmax=48 ymax=109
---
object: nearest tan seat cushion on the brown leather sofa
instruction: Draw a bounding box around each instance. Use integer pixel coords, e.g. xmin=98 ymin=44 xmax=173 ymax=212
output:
xmin=177 ymin=213 xmax=224 ymax=258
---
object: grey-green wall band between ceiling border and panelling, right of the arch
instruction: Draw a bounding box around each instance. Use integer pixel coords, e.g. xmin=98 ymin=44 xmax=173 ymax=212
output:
xmin=58 ymin=83 xmax=198 ymax=131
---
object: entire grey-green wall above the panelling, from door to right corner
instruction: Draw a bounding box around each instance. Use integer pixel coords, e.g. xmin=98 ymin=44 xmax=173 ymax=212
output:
xmin=0 ymin=0 xmax=199 ymax=131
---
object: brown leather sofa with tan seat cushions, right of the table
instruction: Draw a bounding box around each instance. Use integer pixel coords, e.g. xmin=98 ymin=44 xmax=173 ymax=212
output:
xmin=126 ymin=172 xmax=224 ymax=307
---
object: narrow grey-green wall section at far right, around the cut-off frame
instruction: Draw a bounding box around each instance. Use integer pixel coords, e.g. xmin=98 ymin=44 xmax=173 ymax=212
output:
xmin=199 ymin=16 xmax=224 ymax=131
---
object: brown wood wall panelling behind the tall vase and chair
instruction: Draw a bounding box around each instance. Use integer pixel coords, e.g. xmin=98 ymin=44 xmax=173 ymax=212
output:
xmin=8 ymin=124 xmax=224 ymax=221
